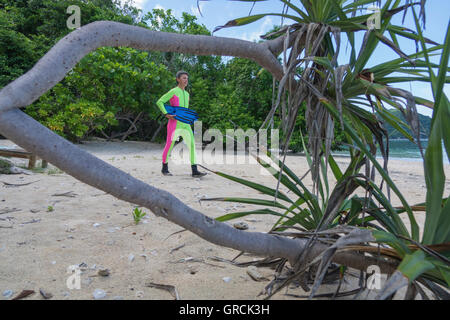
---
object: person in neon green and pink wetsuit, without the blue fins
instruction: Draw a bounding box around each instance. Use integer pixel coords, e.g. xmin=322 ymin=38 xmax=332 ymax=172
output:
xmin=156 ymin=70 xmax=206 ymax=177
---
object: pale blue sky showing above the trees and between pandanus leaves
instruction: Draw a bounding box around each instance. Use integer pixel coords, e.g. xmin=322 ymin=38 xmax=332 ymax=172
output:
xmin=122 ymin=0 xmax=450 ymax=115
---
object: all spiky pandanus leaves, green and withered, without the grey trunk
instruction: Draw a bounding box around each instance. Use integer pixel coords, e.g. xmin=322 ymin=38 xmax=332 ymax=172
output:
xmin=204 ymin=0 xmax=450 ymax=299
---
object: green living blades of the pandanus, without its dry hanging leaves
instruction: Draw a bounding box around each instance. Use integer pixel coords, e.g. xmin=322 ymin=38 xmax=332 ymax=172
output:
xmin=205 ymin=0 xmax=450 ymax=296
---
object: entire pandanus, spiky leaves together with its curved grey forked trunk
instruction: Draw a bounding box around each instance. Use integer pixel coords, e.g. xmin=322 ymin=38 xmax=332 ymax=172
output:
xmin=0 ymin=0 xmax=450 ymax=298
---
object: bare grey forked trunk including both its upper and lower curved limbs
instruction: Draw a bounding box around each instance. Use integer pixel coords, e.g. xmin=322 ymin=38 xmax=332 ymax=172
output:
xmin=0 ymin=21 xmax=395 ymax=273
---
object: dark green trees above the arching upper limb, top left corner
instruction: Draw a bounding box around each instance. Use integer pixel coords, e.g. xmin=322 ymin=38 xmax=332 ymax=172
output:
xmin=0 ymin=0 xmax=142 ymax=88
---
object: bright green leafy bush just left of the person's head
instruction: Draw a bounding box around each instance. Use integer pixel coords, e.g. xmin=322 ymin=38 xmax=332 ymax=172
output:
xmin=68 ymin=48 xmax=171 ymax=139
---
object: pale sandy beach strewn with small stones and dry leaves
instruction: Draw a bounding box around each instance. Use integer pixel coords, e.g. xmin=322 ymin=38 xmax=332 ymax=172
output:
xmin=0 ymin=140 xmax=450 ymax=300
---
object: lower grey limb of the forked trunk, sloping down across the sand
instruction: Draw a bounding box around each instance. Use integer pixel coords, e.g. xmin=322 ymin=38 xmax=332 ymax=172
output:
xmin=0 ymin=109 xmax=395 ymax=273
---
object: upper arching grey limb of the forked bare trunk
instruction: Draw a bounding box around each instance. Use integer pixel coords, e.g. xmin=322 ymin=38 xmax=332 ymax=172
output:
xmin=0 ymin=21 xmax=283 ymax=112
